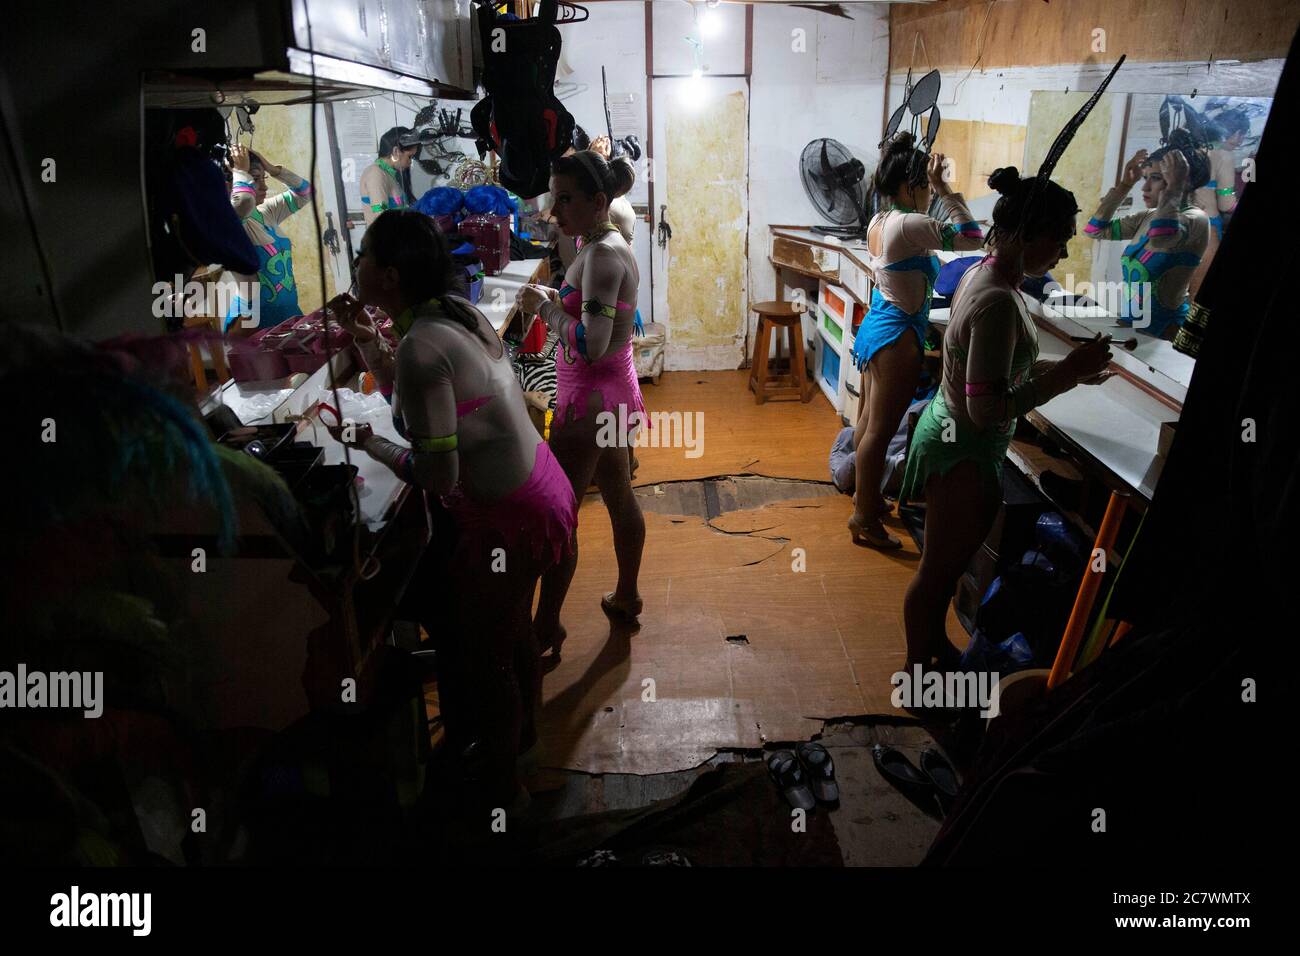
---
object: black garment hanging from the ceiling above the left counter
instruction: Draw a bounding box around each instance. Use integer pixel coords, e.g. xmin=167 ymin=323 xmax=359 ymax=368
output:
xmin=469 ymin=0 xmax=573 ymax=199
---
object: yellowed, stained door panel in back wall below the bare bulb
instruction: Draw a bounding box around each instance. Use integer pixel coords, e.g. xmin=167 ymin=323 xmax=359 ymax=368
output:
xmin=667 ymin=92 xmax=746 ymax=358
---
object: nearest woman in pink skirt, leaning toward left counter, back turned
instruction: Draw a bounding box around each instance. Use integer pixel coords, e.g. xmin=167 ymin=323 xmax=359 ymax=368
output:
xmin=329 ymin=209 xmax=577 ymax=806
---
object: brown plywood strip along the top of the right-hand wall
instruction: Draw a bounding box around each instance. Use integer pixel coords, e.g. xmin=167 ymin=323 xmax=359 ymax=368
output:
xmin=889 ymin=0 xmax=1300 ymax=70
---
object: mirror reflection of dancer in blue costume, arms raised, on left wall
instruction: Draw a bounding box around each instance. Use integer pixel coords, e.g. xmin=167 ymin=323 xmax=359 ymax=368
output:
xmin=224 ymin=144 xmax=312 ymax=334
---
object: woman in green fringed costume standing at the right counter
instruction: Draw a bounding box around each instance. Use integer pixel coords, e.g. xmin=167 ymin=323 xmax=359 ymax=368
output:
xmin=901 ymin=166 xmax=1110 ymax=670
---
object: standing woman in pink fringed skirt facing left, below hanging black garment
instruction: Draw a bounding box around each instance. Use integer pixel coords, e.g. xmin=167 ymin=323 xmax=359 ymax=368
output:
xmin=517 ymin=150 xmax=645 ymax=657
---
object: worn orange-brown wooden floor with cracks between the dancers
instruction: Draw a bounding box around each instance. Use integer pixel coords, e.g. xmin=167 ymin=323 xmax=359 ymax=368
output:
xmin=527 ymin=372 xmax=965 ymax=773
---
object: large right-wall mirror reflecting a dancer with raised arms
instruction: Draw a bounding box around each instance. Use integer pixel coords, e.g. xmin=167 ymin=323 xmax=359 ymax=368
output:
xmin=1024 ymin=91 xmax=1273 ymax=388
